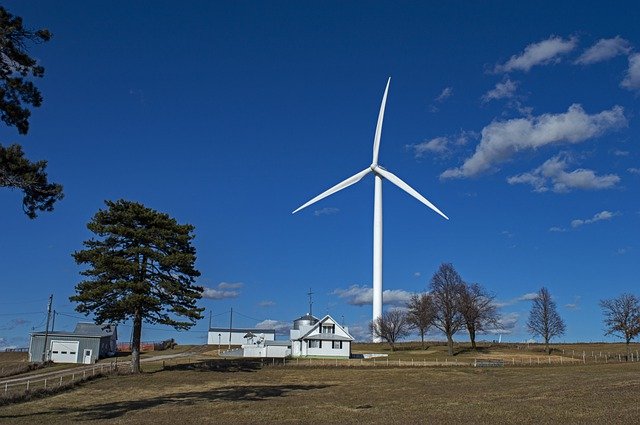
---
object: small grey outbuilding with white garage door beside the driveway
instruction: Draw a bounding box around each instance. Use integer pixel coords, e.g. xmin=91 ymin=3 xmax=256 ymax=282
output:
xmin=29 ymin=322 xmax=118 ymax=364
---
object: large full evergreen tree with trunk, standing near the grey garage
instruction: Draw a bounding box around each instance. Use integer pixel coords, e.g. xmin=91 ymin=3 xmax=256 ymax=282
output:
xmin=70 ymin=200 xmax=204 ymax=372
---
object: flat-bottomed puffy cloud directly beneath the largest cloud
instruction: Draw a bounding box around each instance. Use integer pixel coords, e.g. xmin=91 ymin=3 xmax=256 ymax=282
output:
xmin=507 ymin=155 xmax=620 ymax=193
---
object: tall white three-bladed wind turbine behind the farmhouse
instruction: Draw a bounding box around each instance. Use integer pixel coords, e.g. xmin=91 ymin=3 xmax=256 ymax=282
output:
xmin=292 ymin=77 xmax=449 ymax=342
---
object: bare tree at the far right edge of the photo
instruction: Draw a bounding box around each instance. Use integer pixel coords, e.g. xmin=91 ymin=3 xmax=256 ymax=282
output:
xmin=600 ymin=294 xmax=640 ymax=361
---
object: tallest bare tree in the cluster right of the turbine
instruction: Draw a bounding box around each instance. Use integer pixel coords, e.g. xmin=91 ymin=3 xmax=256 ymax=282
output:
xmin=430 ymin=263 xmax=464 ymax=356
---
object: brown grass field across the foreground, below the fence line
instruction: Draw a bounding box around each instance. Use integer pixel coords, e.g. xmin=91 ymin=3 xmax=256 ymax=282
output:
xmin=0 ymin=344 xmax=640 ymax=424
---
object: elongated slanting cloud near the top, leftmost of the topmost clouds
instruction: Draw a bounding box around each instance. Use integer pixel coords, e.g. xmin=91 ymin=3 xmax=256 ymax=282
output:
xmin=494 ymin=36 xmax=578 ymax=72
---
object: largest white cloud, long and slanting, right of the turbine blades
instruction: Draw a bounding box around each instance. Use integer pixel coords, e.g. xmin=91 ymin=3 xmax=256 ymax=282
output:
xmin=440 ymin=104 xmax=627 ymax=179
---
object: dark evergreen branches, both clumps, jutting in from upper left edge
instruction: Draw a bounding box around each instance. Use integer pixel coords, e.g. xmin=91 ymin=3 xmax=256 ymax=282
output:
xmin=0 ymin=6 xmax=63 ymax=219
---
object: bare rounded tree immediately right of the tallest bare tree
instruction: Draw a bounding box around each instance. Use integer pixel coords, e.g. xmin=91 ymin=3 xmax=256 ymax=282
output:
xmin=460 ymin=283 xmax=499 ymax=350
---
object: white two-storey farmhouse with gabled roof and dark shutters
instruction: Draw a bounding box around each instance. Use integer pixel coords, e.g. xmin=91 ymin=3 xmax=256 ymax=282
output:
xmin=290 ymin=314 xmax=354 ymax=358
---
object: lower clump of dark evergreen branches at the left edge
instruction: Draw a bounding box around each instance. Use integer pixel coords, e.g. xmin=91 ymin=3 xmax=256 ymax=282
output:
xmin=0 ymin=145 xmax=64 ymax=218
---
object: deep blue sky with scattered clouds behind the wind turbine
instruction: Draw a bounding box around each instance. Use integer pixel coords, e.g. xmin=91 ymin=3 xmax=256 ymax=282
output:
xmin=0 ymin=1 xmax=640 ymax=348
